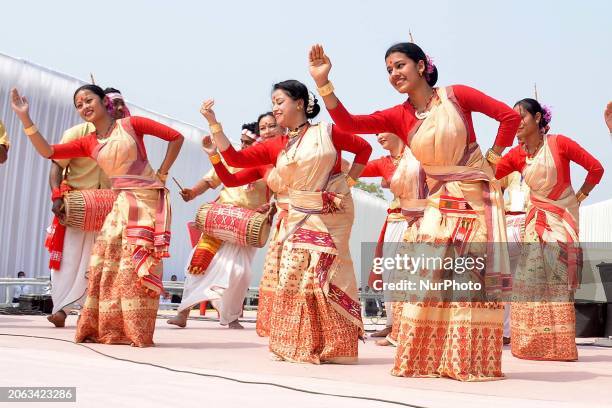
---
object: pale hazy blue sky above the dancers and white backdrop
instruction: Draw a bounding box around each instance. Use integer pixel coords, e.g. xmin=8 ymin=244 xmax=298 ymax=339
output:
xmin=0 ymin=0 xmax=612 ymax=204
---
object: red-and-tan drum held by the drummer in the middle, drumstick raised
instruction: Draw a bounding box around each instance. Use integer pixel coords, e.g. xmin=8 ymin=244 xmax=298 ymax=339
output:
xmin=196 ymin=203 xmax=270 ymax=248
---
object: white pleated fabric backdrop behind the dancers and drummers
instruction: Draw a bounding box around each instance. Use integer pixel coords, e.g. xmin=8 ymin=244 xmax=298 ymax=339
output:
xmin=0 ymin=54 xmax=386 ymax=303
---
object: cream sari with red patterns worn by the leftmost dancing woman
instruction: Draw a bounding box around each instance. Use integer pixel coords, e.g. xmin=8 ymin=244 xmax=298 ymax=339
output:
xmin=75 ymin=118 xmax=171 ymax=347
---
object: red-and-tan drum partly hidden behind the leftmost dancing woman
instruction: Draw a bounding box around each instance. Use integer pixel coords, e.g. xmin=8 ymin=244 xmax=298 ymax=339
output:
xmin=64 ymin=190 xmax=117 ymax=231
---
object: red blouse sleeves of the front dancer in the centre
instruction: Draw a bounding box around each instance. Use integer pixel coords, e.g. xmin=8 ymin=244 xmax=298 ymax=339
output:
xmin=221 ymin=125 xmax=372 ymax=174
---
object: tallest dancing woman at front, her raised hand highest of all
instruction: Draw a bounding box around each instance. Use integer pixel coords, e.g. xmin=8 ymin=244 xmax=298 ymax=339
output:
xmin=309 ymin=43 xmax=520 ymax=381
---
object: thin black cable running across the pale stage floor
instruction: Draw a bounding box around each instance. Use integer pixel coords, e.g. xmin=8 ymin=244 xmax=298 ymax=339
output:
xmin=0 ymin=333 xmax=426 ymax=408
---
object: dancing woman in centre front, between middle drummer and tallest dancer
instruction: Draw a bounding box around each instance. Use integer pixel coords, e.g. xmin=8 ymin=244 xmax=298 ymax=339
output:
xmin=202 ymin=80 xmax=372 ymax=364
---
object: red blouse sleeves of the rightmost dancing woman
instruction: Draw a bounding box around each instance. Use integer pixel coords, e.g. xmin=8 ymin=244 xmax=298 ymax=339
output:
xmin=495 ymin=135 xmax=604 ymax=184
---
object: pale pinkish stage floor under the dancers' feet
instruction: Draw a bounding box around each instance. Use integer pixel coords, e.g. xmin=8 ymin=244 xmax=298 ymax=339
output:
xmin=0 ymin=315 xmax=612 ymax=408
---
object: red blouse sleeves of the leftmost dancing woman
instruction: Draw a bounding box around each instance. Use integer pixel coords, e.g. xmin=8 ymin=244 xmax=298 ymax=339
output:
xmin=48 ymin=116 xmax=182 ymax=160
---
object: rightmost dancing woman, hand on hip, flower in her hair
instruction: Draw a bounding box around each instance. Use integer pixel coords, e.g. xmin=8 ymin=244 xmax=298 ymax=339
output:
xmin=495 ymin=98 xmax=604 ymax=361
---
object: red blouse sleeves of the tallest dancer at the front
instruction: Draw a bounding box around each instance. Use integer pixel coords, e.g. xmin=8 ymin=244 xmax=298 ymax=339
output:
xmin=328 ymin=85 xmax=521 ymax=147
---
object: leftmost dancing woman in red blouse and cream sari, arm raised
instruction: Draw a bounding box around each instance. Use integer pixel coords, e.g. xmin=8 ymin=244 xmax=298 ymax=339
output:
xmin=11 ymin=85 xmax=183 ymax=347
